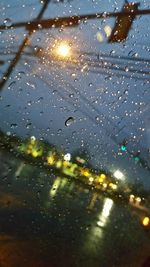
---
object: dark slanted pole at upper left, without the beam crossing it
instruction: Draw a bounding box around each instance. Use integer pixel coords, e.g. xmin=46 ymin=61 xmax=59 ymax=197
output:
xmin=0 ymin=0 xmax=50 ymax=91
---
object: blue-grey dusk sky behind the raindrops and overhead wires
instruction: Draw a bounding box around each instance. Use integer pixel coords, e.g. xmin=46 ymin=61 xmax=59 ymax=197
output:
xmin=0 ymin=0 xmax=150 ymax=186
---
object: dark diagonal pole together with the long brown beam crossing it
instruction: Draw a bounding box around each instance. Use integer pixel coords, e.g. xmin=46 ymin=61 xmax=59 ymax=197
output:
xmin=0 ymin=4 xmax=150 ymax=91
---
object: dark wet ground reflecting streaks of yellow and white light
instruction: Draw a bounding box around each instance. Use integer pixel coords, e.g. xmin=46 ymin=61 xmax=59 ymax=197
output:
xmin=0 ymin=151 xmax=150 ymax=267
